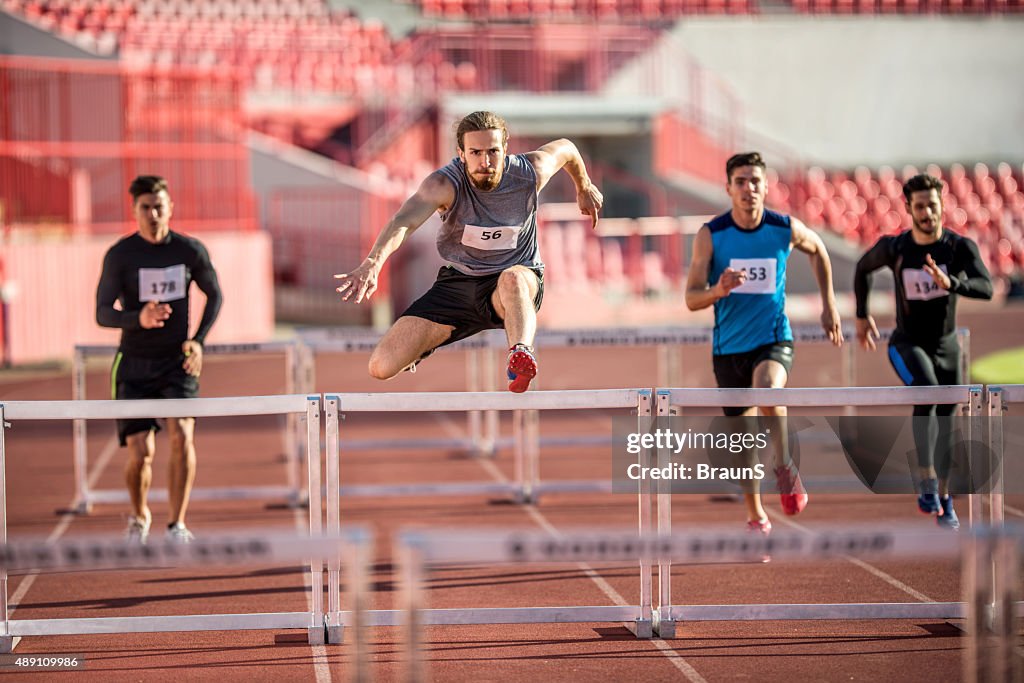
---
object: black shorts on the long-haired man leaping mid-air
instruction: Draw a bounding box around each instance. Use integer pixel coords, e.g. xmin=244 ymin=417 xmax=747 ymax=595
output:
xmin=402 ymin=265 xmax=544 ymax=346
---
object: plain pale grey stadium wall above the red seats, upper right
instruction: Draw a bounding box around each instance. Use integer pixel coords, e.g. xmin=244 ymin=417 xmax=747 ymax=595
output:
xmin=657 ymin=14 xmax=1024 ymax=168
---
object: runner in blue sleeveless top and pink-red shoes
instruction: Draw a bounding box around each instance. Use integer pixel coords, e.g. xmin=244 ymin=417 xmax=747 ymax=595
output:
xmin=686 ymin=152 xmax=843 ymax=535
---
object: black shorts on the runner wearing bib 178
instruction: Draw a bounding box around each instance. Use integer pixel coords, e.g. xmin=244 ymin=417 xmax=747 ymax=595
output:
xmin=111 ymin=351 xmax=199 ymax=445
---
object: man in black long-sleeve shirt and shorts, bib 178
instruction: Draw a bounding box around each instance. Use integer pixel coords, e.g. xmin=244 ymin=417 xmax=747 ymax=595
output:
xmin=96 ymin=175 xmax=221 ymax=543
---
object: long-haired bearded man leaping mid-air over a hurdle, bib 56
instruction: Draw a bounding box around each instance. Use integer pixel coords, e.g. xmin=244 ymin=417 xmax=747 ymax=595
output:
xmin=335 ymin=112 xmax=604 ymax=393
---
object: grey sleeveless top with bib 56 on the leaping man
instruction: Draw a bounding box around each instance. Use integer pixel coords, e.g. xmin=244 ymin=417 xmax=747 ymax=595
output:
xmin=437 ymin=155 xmax=544 ymax=275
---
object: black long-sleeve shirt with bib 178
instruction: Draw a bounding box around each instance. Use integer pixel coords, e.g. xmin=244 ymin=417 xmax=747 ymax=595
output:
xmin=96 ymin=231 xmax=223 ymax=358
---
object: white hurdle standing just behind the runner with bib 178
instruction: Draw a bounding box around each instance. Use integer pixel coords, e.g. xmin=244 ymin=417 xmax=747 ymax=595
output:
xmin=72 ymin=342 xmax=310 ymax=514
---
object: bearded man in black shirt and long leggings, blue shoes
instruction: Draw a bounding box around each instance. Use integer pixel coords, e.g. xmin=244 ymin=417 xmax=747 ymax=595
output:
xmin=853 ymin=174 xmax=992 ymax=528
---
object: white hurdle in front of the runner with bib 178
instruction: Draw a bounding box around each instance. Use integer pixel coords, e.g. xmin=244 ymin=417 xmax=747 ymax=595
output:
xmin=0 ymin=395 xmax=325 ymax=652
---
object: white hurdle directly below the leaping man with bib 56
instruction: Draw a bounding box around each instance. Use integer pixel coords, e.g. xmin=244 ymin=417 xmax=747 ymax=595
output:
xmin=324 ymin=389 xmax=653 ymax=643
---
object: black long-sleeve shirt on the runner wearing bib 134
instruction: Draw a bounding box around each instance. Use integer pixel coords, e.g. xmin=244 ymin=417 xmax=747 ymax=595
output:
xmin=853 ymin=229 xmax=992 ymax=347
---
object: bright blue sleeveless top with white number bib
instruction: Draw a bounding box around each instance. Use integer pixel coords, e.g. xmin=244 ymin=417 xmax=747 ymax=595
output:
xmin=708 ymin=210 xmax=793 ymax=355
